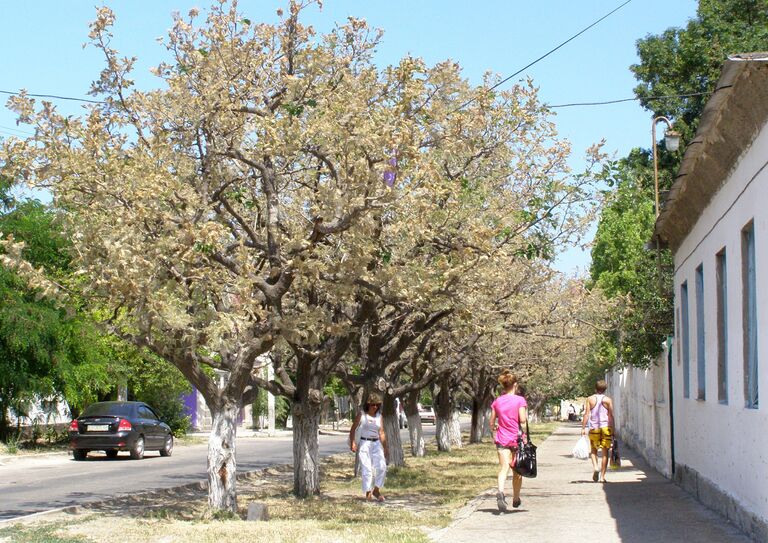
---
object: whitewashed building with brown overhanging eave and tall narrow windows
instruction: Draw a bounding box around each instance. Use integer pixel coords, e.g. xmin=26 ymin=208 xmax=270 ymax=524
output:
xmin=655 ymin=54 xmax=768 ymax=541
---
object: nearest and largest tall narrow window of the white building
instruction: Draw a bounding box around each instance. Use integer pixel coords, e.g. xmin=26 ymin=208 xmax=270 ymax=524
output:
xmin=741 ymin=221 xmax=758 ymax=409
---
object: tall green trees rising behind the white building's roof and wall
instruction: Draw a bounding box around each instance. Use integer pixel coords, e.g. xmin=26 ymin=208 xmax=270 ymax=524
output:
xmin=580 ymin=0 xmax=768 ymax=380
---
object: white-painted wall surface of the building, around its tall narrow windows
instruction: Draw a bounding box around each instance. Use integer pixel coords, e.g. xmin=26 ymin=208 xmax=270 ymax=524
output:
xmin=673 ymin=120 xmax=768 ymax=521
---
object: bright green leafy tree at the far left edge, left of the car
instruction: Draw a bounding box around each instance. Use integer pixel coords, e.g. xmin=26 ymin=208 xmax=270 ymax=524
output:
xmin=0 ymin=187 xmax=110 ymax=437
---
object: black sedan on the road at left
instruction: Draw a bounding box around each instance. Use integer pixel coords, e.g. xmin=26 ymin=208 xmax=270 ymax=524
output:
xmin=69 ymin=402 xmax=173 ymax=460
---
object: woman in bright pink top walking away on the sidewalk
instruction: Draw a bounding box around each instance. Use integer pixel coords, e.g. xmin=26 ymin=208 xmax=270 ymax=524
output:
xmin=490 ymin=370 xmax=528 ymax=511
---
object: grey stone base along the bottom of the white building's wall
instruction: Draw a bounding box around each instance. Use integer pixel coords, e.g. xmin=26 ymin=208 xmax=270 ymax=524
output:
xmin=674 ymin=463 xmax=768 ymax=541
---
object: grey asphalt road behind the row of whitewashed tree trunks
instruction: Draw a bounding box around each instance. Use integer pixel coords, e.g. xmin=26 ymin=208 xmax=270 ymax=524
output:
xmin=0 ymin=425 xmax=434 ymax=520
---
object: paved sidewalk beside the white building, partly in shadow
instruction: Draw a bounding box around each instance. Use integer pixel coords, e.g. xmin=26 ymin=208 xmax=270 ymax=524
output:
xmin=432 ymin=425 xmax=751 ymax=543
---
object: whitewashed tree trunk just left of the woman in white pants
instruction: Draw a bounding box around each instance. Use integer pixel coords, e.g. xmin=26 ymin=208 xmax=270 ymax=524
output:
xmin=292 ymin=391 xmax=322 ymax=498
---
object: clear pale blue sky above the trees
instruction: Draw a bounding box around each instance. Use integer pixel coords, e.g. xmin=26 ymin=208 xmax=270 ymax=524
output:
xmin=0 ymin=0 xmax=697 ymax=272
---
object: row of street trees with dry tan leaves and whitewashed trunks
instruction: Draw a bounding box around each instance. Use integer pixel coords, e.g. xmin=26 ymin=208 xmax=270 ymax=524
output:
xmin=0 ymin=0 xmax=604 ymax=510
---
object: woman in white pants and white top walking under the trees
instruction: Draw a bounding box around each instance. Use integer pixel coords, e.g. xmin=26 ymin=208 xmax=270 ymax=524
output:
xmin=349 ymin=392 xmax=389 ymax=502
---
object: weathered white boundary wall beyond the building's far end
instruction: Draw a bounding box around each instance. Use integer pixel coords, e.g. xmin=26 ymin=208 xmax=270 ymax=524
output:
xmin=606 ymin=346 xmax=671 ymax=477
